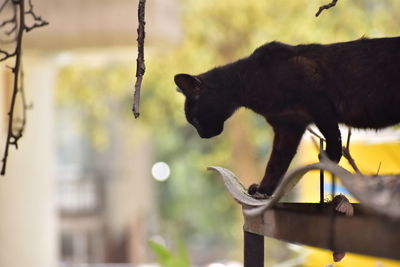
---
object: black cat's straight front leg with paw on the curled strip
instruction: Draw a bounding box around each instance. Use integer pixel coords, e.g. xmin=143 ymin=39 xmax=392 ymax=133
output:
xmin=248 ymin=124 xmax=305 ymax=196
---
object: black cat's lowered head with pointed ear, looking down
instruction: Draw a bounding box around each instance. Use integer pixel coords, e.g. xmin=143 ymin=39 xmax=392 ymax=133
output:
xmin=174 ymin=74 xmax=232 ymax=138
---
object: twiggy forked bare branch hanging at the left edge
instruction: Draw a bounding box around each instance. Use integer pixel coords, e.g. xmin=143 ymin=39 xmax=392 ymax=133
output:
xmin=0 ymin=0 xmax=48 ymax=175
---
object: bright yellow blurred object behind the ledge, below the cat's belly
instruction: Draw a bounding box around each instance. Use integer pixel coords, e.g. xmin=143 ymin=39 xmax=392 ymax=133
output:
xmin=297 ymin=130 xmax=400 ymax=267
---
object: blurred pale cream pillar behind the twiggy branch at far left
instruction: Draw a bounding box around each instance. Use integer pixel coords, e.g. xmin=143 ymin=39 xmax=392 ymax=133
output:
xmin=0 ymin=55 xmax=58 ymax=267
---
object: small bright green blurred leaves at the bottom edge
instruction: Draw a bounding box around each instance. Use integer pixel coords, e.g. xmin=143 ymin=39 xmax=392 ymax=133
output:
xmin=149 ymin=241 xmax=191 ymax=267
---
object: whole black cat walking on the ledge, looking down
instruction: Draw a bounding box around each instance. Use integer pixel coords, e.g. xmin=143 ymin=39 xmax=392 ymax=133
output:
xmin=175 ymin=37 xmax=400 ymax=195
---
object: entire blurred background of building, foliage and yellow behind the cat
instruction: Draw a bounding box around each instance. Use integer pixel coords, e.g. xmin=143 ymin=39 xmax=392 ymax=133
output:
xmin=0 ymin=0 xmax=400 ymax=267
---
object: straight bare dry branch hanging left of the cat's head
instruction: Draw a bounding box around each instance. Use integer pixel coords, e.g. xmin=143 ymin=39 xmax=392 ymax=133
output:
xmin=132 ymin=0 xmax=146 ymax=118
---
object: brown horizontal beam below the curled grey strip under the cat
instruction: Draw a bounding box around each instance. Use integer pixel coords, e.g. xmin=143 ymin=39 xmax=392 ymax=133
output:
xmin=244 ymin=203 xmax=400 ymax=260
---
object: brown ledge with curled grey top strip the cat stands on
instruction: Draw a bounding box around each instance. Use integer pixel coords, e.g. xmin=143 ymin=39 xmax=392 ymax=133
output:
xmin=209 ymin=165 xmax=400 ymax=262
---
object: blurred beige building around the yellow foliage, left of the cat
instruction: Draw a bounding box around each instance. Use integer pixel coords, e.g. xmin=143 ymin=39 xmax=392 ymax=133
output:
xmin=0 ymin=0 xmax=179 ymax=267
